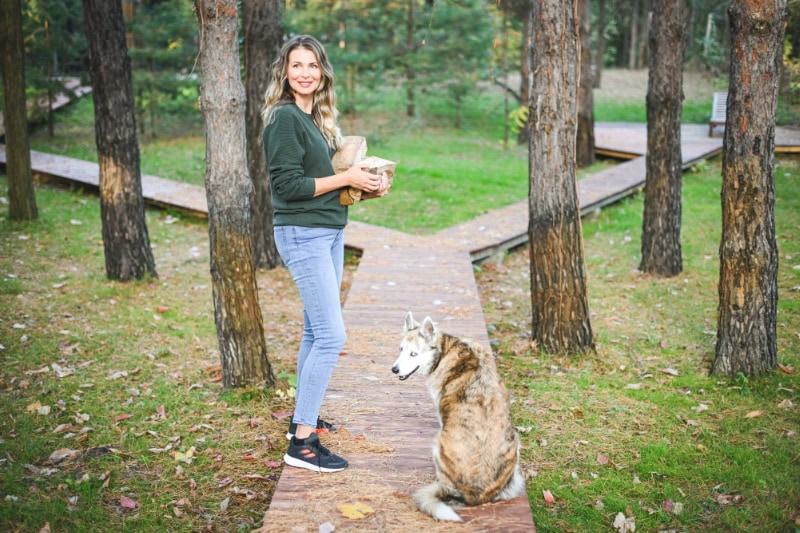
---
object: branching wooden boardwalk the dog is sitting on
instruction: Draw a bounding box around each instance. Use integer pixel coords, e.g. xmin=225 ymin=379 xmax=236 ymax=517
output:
xmin=0 ymin=124 xmax=800 ymax=533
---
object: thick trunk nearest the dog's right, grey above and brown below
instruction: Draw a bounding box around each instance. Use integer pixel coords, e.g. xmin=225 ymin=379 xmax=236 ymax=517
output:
xmin=528 ymin=0 xmax=594 ymax=353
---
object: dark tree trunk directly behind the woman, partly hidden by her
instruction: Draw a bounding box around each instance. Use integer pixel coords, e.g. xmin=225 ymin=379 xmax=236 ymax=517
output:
xmin=242 ymin=0 xmax=283 ymax=269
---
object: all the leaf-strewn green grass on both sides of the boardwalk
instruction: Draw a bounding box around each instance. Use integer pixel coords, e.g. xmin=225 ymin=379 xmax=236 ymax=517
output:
xmin=6 ymin=74 xmax=800 ymax=532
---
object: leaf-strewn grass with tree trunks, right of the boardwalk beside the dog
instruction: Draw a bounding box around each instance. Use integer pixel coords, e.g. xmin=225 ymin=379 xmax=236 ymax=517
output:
xmin=477 ymin=157 xmax=800 ymax=532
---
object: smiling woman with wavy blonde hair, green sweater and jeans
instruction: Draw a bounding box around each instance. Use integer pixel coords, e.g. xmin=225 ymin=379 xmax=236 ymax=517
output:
xmin=263 ymin=35 xmax=385 ymax=472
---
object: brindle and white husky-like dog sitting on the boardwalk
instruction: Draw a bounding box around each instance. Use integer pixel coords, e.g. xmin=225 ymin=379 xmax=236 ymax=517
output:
xmin=392 ymin=311 xmax=525 ymax=522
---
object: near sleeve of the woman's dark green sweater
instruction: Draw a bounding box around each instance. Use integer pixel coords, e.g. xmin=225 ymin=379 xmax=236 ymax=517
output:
xmin=263 ymin=110 xmax=316 ymax=202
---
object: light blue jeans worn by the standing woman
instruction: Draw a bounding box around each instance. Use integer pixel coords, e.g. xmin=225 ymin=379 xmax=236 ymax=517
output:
xmin=274 ymin=226 xmax=346 ymax=428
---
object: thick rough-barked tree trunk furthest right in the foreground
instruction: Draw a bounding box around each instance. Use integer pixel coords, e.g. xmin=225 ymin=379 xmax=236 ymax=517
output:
xmin=712 ymin=0 xmax=786 ymax=377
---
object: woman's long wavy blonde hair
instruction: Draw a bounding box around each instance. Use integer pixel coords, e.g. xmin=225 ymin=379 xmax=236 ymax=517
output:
xmin=261 ymin=35 xmax=342 ymax=150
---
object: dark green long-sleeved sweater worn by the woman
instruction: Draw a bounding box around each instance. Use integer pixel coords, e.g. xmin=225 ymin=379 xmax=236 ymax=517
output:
xmin=262 ymin=104 xmax=347 ymax=228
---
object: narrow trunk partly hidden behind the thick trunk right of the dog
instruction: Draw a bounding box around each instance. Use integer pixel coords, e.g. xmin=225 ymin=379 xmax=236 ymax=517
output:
xmin=575 ymin=0 xmax=594 ymax=167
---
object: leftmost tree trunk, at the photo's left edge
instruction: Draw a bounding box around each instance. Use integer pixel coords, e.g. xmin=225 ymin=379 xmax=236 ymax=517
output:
xmin=0 ymin=0 xmax=38 ymax=220
